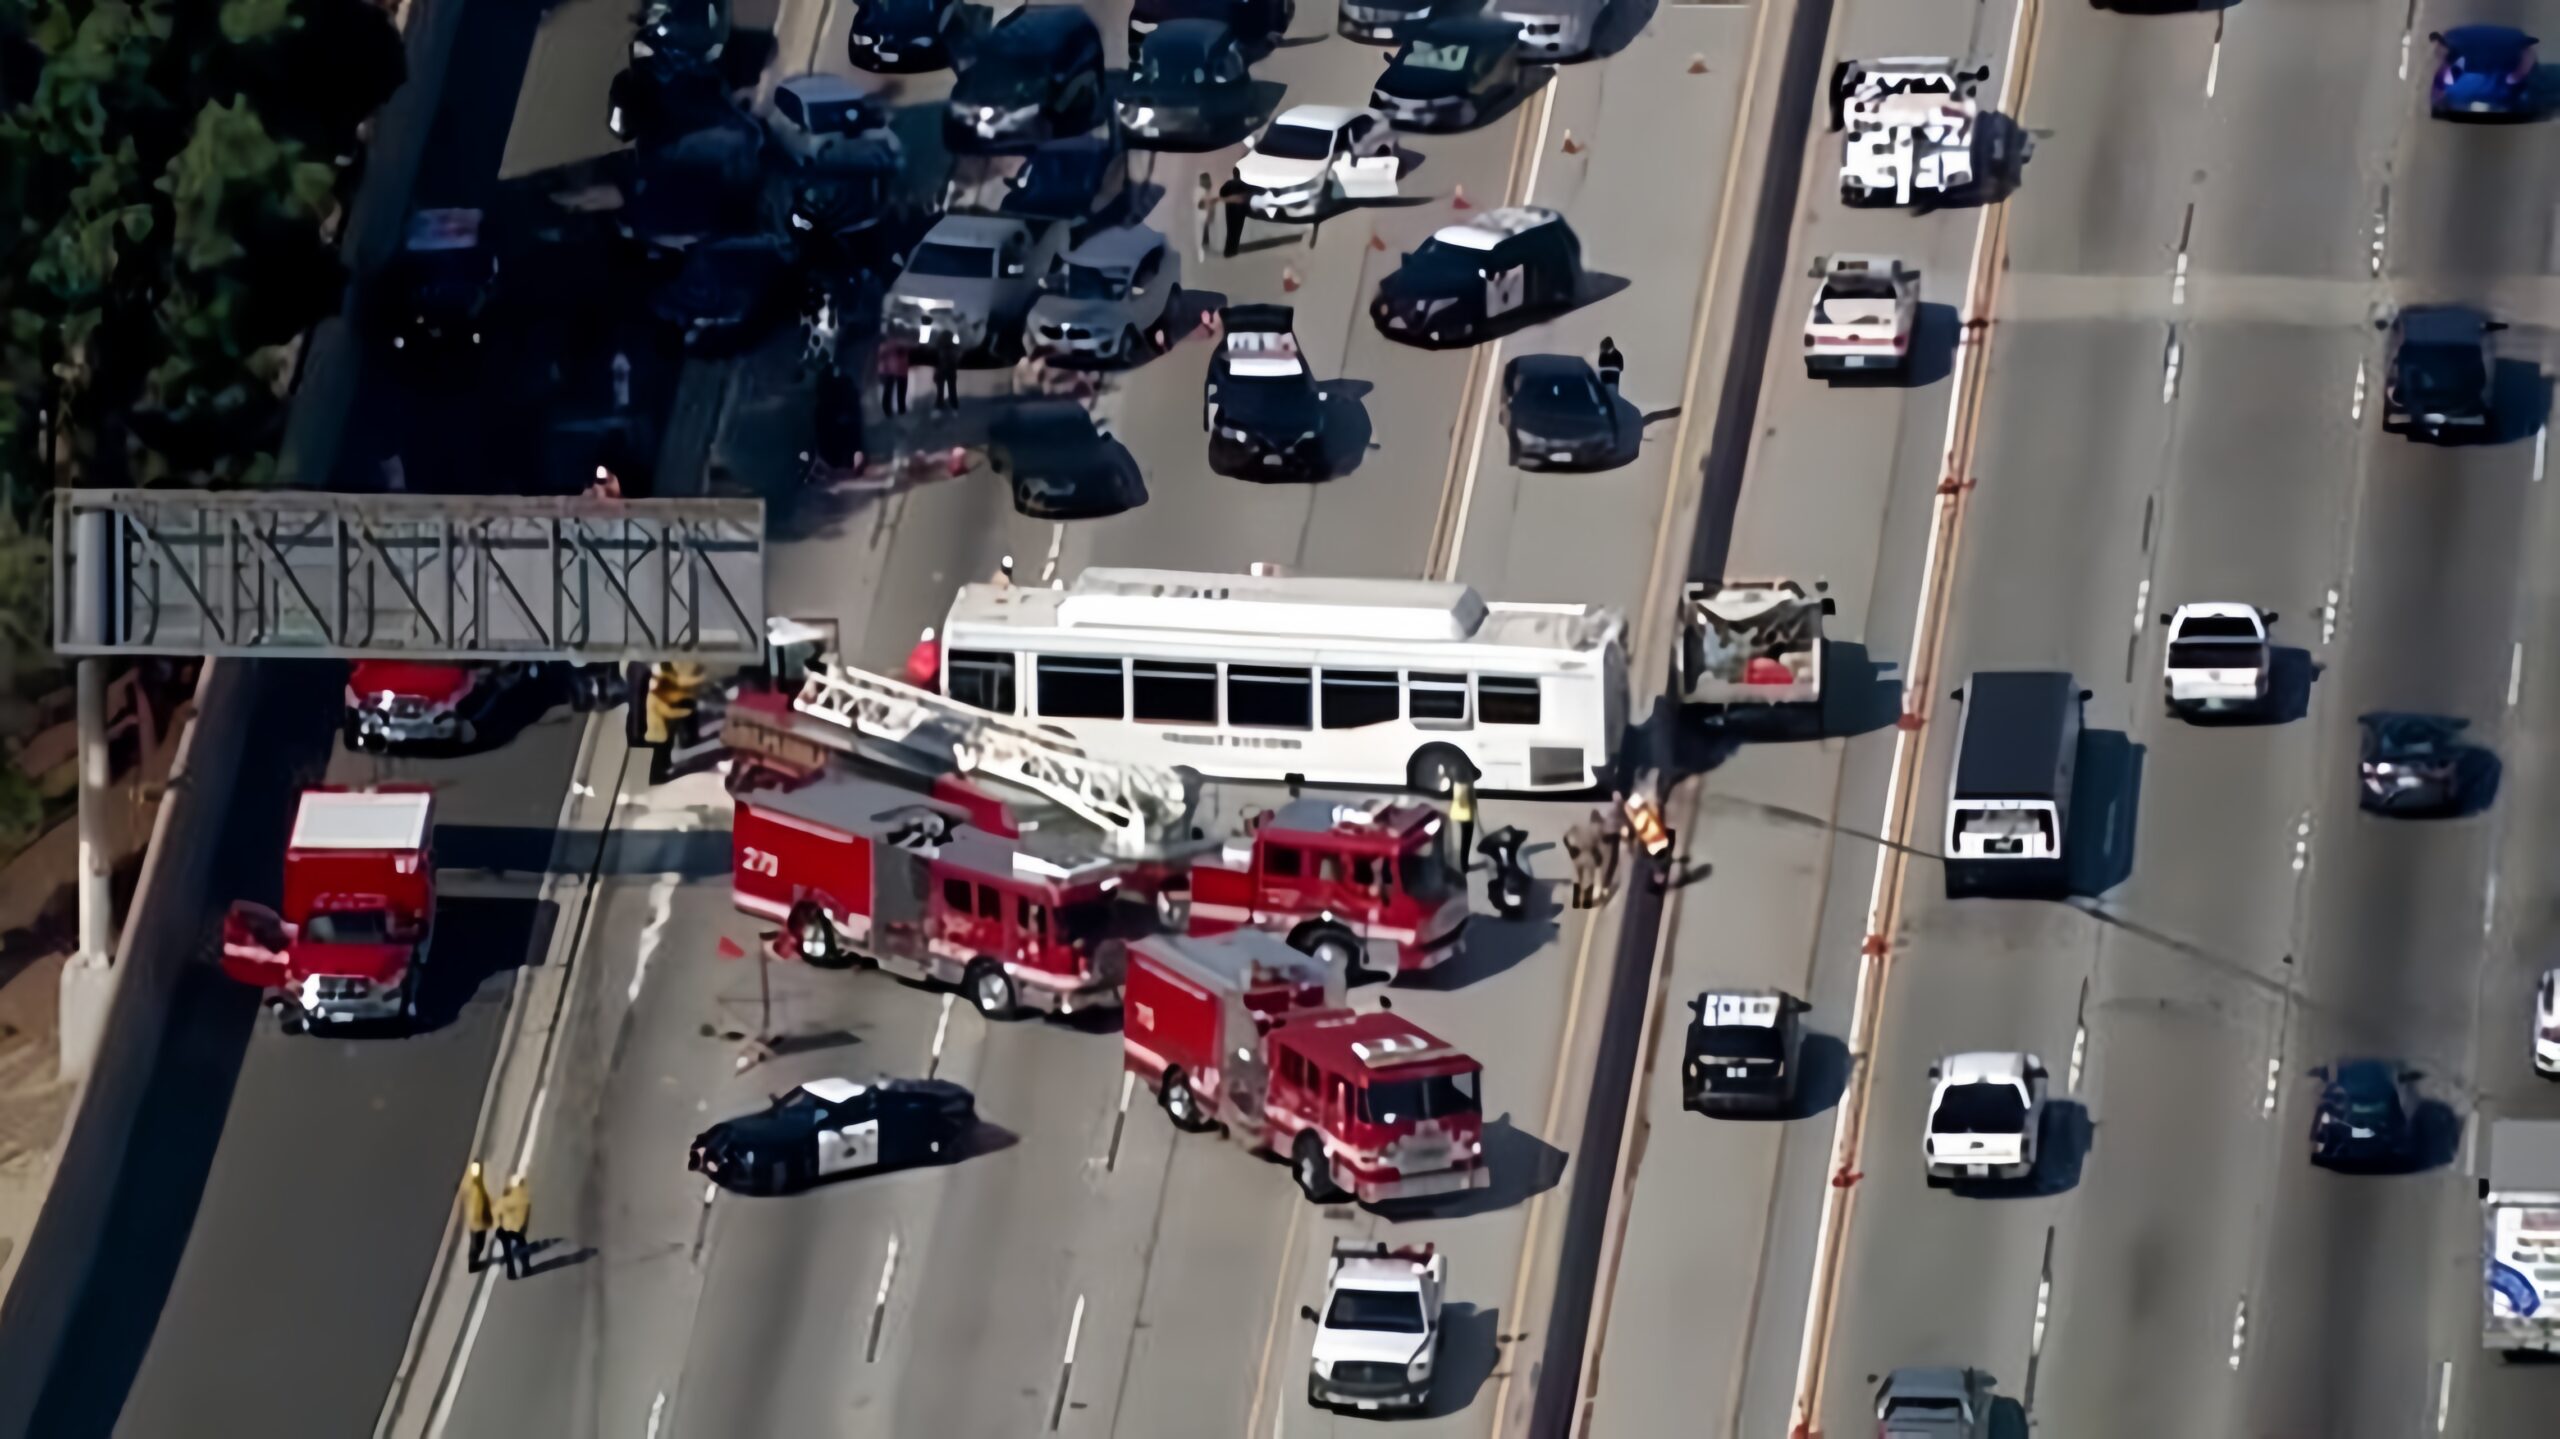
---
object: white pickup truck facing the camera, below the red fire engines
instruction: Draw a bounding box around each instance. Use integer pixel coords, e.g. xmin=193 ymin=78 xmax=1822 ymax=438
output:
xmin=1298 ymin=1239 xmax=1449 ymax=1411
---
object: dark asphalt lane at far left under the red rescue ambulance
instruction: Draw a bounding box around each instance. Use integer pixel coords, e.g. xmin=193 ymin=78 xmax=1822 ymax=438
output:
xmin=64 ymin=709 xmax=593 ymax=1434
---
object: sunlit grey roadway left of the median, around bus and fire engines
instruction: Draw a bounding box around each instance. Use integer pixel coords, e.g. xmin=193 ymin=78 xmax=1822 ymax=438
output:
xmin=445 ymin=8 xmax=1751 ymax=1436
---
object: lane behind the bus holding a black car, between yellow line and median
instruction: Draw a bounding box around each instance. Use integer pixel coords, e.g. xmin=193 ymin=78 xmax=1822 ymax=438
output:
xmin=1454 ymin=10 xmax=1751 ymax=617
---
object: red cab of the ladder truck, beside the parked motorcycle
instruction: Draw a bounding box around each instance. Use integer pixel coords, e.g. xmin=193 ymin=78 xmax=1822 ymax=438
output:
xmin=1188 ymin=799 xmax=1467 ymax=976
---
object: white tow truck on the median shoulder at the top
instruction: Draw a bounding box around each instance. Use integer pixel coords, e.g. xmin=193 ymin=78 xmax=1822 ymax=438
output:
xmin=1833 ymin=59 xmax=1997 ymax=205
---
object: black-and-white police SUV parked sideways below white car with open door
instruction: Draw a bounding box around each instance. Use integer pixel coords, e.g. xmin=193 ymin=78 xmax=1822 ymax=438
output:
xmin=1370 ymin=205 xmax=1582 ymax=348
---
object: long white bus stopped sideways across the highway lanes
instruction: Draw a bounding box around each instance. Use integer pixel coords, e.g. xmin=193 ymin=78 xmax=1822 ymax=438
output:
xmin=942 ymin=568 xmax=1626 ymax=794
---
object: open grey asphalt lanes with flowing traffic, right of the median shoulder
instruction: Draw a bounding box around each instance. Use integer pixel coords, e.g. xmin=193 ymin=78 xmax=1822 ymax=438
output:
xmin=1710 ymin=0 xmax=2560 ymax=1439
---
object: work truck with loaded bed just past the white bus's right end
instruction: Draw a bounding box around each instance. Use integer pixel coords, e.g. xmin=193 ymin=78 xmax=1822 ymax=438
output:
xmin=1672 ymin=579 xmax=1838 ymax=720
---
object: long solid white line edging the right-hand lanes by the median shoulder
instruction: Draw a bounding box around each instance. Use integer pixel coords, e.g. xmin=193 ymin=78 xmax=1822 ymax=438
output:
xmin=1792 ymin=0 xmax=2038 ymax=1426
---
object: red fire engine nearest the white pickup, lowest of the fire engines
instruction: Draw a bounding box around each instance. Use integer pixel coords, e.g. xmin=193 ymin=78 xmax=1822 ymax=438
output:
xmin=1121 ymin=929 xmax=1492 ymax=1203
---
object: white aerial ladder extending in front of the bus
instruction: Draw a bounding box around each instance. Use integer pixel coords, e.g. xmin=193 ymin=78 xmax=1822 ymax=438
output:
xmin=791 ymin=655 xmax=1198 ymax=855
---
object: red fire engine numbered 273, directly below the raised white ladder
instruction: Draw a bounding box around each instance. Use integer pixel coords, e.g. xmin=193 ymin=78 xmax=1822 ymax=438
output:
xmin=730 ymin=776 xmax=1139 ymax=1017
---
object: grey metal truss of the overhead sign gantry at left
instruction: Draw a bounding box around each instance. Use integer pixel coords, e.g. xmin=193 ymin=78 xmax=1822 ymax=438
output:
xmin=54 ymin=489 xmax=765 ymax=663
